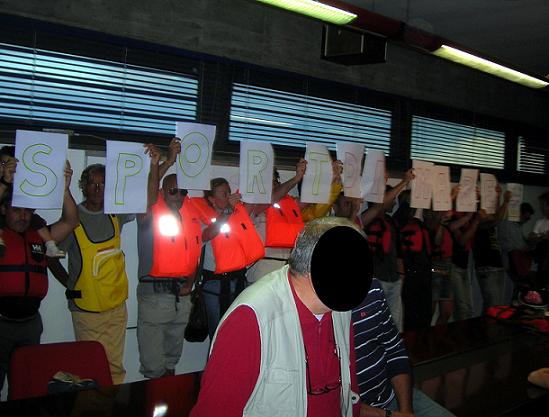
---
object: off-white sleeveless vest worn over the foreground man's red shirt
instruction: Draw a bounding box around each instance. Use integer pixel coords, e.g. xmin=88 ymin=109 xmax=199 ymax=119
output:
xmin=212 ymin=266 xmax=358 ymax=417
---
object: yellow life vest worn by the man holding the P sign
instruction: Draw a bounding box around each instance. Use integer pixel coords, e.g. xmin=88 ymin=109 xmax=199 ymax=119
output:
xmin=73 ymin=214 xmax=128 ymax=312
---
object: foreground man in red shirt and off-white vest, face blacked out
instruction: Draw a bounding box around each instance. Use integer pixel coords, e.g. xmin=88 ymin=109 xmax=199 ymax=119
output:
xmin=191 ymin=217 xmax=371 ymax=417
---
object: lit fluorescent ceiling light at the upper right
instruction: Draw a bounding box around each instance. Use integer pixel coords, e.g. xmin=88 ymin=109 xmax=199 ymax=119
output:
xmin=432 ymin=45 xmax=549 ymax=88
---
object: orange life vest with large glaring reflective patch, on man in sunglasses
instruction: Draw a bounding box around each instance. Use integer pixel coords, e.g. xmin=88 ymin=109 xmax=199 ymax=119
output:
xmin=149 ymin=193 xmax=202 ymax=278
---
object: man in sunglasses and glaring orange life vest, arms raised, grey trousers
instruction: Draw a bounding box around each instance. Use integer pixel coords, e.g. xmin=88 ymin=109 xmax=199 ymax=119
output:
xmin=137 ymin=140 xmax=202 ymax=378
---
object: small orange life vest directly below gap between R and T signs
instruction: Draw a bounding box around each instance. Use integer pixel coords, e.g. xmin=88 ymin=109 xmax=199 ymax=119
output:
xmin=265 ymin=195 xmax=304 ymax=248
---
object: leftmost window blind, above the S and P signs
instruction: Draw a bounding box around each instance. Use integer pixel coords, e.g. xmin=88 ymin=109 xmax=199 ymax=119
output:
xmin=0 ymin=43 xmax=198 ymax=134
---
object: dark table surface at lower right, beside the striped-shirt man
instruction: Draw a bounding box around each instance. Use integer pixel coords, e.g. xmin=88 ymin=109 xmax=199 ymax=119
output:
xmin=404 ymin=317 xmax=549 ymax=417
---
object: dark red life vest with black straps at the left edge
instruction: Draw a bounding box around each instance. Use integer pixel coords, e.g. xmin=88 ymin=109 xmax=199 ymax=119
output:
xmin=0 ymin=228 xmax=48 ymax=300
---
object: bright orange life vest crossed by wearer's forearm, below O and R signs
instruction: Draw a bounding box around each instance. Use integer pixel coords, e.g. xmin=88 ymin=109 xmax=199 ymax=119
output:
xmin=191 ymin=198 xmax=265 ymax=274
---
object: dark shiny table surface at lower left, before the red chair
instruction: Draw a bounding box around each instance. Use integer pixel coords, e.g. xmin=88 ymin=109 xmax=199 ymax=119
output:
xmin=0 ymin=373 xmax=198 ymax=417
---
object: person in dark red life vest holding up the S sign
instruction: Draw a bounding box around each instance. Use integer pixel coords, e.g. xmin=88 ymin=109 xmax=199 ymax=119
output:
xmin=0 ymin=159 xmax=78 ymax=390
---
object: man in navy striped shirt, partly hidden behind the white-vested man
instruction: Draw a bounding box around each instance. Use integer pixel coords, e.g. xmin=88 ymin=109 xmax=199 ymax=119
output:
xmin=352 ymin=279 xmax=453 ymax=417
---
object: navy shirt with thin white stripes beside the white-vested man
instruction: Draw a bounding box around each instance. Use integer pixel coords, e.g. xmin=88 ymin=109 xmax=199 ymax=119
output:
xmin=352 ymin=278 xmax=411 ymax=408
